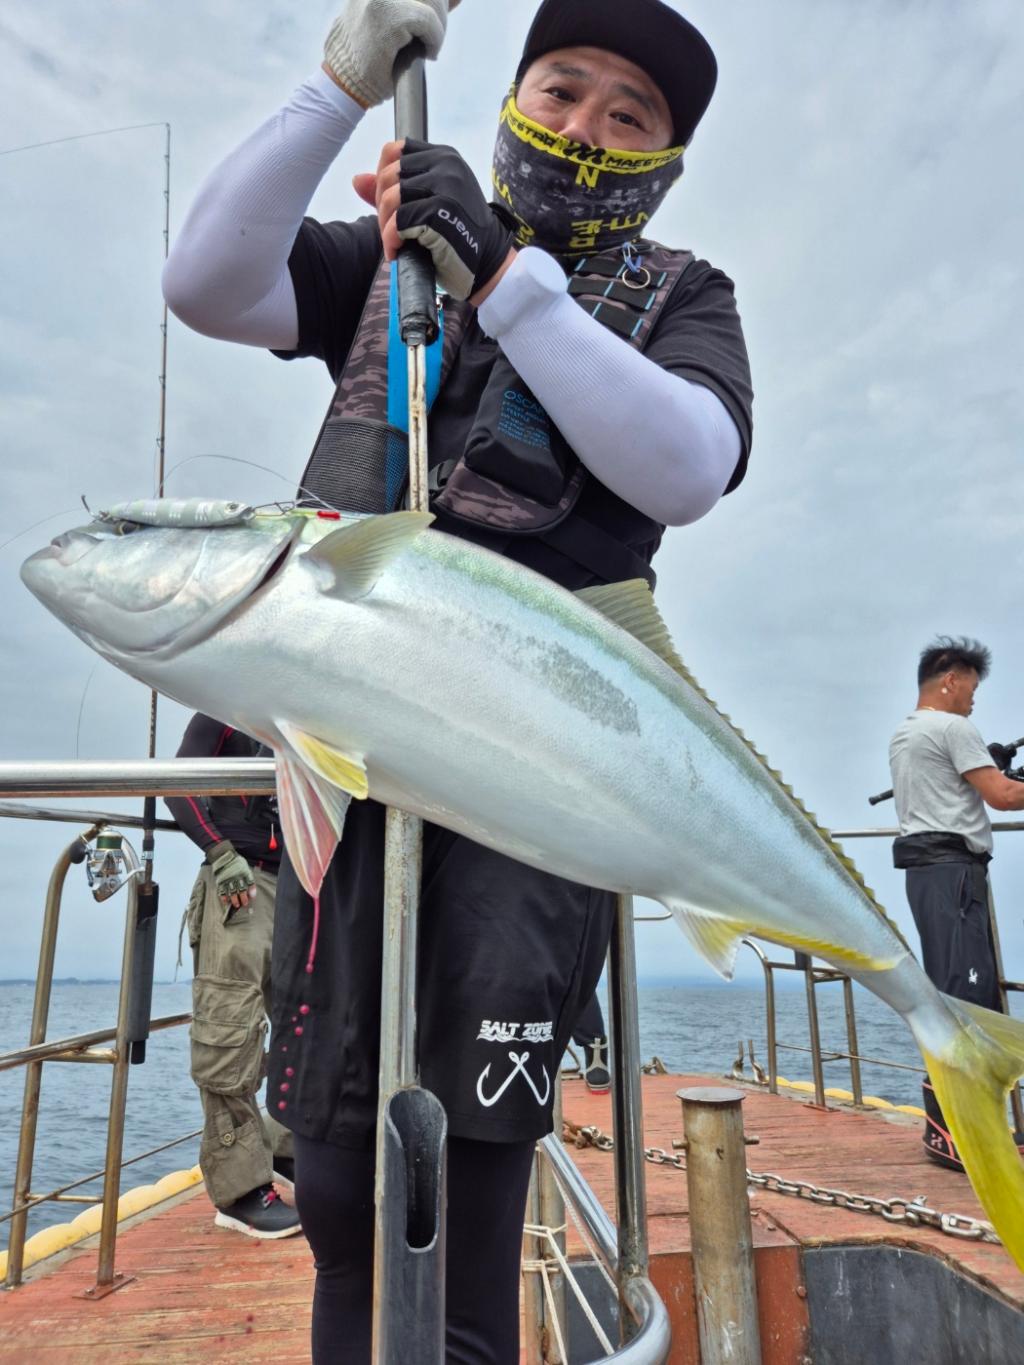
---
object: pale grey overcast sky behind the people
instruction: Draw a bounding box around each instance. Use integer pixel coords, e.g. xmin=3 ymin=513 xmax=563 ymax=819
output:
xmin=0 ymin=0 xmax=1024 ymax=1015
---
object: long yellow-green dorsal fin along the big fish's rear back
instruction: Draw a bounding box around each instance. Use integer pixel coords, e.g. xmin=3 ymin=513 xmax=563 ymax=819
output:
xmin=575 ymin=579 xmax=907 ymax=950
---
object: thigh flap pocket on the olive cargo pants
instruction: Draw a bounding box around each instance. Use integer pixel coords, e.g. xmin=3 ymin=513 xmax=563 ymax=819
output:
xmin=188 ymin=976 xmax=266 ymax=1095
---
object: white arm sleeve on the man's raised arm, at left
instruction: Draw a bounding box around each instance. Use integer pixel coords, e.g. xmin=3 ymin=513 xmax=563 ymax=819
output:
xmin=164 ymin=71 xmax=363 ymax=351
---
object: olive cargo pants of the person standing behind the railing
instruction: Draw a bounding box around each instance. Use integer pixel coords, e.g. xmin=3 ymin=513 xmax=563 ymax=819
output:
xmin=186 ymin=864 xmax=292 ymax=1208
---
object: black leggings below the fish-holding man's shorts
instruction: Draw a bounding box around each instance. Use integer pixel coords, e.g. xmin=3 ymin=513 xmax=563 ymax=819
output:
xmin=295 ymin=1133 xmax=535 ymax=1365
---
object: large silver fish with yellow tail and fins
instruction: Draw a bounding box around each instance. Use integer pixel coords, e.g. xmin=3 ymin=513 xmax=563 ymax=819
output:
xmin=22 ymin=502 xmax=1024 ymax=1265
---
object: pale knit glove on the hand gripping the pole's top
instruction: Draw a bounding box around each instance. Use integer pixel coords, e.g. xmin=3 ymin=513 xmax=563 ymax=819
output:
xmin=324 ymin=0 xmax=459 ymax=109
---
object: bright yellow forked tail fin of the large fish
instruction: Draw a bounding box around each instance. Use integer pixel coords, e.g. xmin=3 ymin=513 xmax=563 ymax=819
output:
xmin=919 ymin=996 xmax=1024 ymax=1269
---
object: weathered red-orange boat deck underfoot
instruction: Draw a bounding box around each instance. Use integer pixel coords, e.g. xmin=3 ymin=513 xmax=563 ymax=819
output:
xmin=0 ymin=1076 xmax=1024 ymax=1365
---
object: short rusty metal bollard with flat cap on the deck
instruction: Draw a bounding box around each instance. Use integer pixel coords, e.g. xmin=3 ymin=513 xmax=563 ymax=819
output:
xmin=679 ymin=1087 xmax=760 ymax=1365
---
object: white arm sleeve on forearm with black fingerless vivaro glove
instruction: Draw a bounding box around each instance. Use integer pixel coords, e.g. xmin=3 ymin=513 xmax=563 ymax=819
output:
xmin=478 ymin=247 xmax=741 ymax=526
